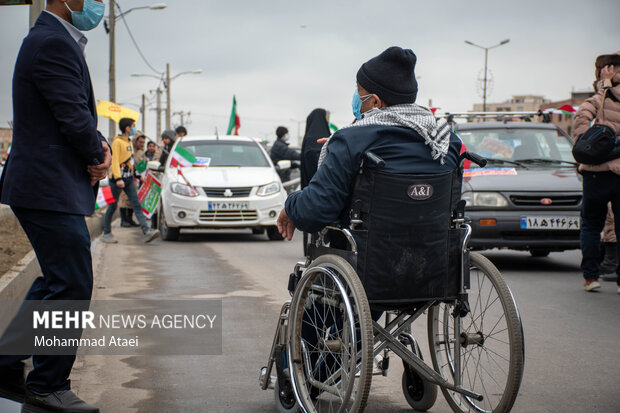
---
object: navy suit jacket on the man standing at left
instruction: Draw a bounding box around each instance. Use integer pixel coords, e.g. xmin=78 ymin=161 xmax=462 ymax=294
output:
xmin=0 ymin=12 xmax=105 ymax=215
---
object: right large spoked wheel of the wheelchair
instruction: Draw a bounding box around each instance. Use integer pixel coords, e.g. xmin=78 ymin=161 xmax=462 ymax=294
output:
xmin=428 ymin=253 xmax=524 ymax=413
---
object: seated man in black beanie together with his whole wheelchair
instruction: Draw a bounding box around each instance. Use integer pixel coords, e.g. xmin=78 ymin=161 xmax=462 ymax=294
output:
xmin=261 ymin=47 xmax=523 ymax=412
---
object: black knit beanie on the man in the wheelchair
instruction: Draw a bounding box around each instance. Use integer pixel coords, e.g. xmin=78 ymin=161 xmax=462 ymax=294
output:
xmin=357 ymin=46 xmax=418 ymax=106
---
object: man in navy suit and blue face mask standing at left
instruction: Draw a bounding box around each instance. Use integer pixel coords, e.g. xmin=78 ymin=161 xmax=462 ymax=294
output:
xmin=0 ymin=0 xmax=111 ymax=412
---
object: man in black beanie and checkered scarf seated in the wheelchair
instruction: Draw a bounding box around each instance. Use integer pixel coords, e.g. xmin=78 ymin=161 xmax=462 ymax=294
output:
xmin=278 ymin=47 xmax=462 ymax=240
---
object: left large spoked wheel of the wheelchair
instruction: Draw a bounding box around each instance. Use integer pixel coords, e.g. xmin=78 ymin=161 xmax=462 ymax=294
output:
xmin=288 ymin=255 xmax=373 ymax=412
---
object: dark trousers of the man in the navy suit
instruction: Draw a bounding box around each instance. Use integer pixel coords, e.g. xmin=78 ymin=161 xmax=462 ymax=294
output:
xmin=0 ymin=207 xmax=93 ymax=393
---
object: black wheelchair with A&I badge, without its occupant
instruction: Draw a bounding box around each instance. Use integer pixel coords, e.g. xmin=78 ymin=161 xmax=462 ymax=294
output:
xmin=259 ymin=152 xmax=525 ymax=413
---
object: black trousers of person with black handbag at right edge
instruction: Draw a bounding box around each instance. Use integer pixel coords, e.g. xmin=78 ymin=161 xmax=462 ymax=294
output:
xmin=580 ymin=171 xmax=620 ymax=284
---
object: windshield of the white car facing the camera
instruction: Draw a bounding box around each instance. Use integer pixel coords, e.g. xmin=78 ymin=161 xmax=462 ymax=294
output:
xmin=179 ymin=140 xmax=269 ymax=167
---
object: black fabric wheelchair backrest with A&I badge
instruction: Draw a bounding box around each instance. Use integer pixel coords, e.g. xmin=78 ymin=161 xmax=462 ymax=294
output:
xmin=351 ymin=168 xmax=462 ymax=308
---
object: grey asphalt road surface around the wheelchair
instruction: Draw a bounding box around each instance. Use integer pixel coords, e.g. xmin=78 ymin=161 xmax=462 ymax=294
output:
xmin=0 ymin=225 xmax=620 ymax=413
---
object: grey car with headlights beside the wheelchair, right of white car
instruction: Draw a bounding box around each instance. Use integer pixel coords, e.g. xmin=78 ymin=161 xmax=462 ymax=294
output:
xmin=456 ymin=122 xmax=582 ymax=257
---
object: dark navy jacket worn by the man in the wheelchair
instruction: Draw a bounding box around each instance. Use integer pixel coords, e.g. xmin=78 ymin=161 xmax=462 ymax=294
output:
xmin=285 ymin=125 xmax=462 ymax=232
